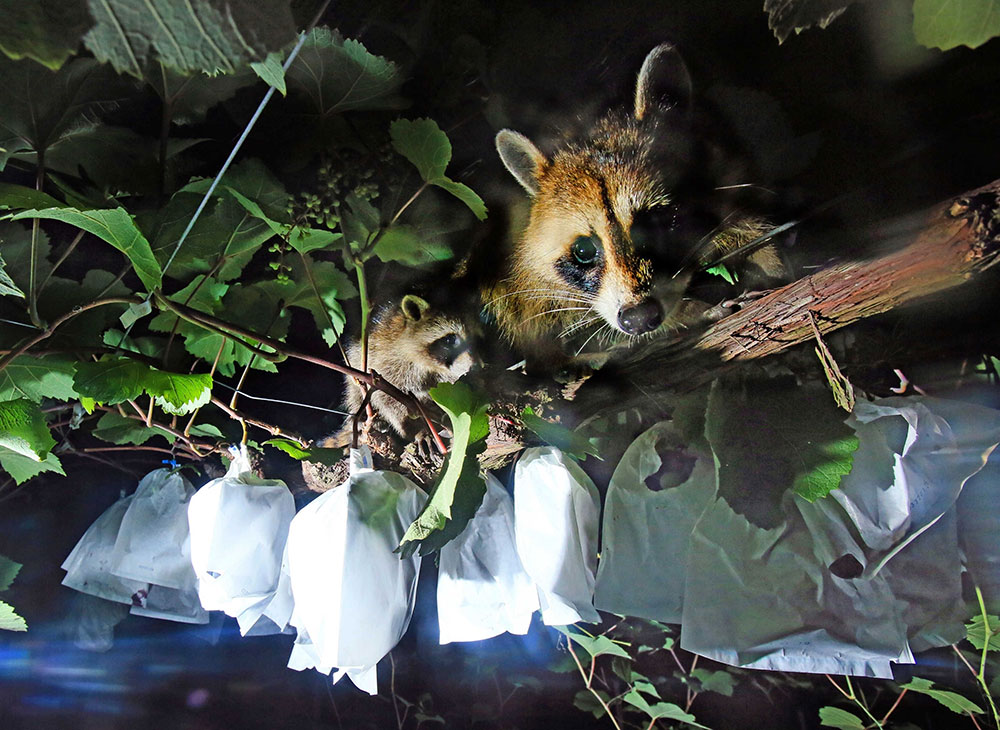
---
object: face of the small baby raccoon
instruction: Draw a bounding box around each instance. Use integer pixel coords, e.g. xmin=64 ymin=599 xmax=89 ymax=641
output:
xmin=401 ymin=294 xmax=475 ymax=383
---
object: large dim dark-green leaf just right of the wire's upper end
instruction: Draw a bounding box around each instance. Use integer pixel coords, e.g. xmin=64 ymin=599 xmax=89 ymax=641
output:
xmin=285 ymin=28 xmax=404 ymax=117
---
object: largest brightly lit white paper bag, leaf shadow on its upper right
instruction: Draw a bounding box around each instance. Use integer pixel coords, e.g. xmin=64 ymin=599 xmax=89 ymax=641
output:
xmin=288 ymin=447 xmax=427 ymax=694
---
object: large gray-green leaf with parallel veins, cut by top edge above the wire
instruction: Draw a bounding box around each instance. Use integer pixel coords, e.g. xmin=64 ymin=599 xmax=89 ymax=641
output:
xmin=83 ymin=0 xmax=295 ymax=78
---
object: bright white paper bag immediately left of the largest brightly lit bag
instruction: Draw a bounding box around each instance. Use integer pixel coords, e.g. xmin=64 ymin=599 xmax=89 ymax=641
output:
xmin=187 ymin=446 xmax=295 ymax=635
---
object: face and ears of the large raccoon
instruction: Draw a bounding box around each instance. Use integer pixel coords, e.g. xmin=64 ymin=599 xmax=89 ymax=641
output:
xmin=496 ymin=45 xmax=701 ymax=336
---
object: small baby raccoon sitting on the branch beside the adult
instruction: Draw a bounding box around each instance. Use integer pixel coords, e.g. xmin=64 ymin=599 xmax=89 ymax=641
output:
xmin=321 ymin=294 xmax=474 ymax=447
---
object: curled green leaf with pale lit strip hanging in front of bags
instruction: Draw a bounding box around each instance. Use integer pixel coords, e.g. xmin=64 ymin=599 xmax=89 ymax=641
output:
xmin=399 ymin=383 xmax=490 ymax=555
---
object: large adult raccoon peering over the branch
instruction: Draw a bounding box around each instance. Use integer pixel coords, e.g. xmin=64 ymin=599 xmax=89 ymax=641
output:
xmin=482 ymin=44 xmax=782 ymax=359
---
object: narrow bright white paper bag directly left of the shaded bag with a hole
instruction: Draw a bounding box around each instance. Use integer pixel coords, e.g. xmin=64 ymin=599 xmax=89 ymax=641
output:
xmin=514 ymin=446 xmax=601 ymax=626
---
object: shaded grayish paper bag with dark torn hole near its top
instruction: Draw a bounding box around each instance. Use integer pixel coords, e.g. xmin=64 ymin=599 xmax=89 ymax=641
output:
xmin=594 ymin=421 xmax=716 ymax=623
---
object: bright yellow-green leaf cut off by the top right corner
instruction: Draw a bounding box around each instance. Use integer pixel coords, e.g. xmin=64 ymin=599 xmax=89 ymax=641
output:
xmin=913 ymin=0 xmax=1000 ymax=51
